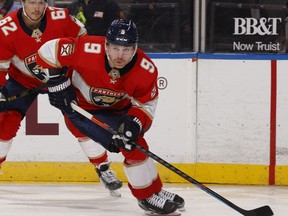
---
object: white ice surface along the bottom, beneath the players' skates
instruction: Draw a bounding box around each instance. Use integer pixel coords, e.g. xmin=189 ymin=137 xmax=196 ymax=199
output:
xmin=0 ymin=183 xmax=288 ymax=216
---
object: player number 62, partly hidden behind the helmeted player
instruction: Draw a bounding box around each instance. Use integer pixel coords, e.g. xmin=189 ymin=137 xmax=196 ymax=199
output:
xmin=0 ymin=0 xmax=122 ymax=196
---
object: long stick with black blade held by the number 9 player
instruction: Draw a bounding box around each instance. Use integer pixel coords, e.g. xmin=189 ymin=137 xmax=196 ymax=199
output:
xmin=71 ymin=103 xmax=274 ymax=216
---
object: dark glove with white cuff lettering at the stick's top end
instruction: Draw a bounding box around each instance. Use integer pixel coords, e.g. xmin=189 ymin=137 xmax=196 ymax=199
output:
xmin=47 ymin=76 xmax=77 ymax=114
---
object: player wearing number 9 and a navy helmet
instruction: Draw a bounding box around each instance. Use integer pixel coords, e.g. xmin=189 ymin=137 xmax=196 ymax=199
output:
xmin=37 ymin=19 xmax=184 ymax=215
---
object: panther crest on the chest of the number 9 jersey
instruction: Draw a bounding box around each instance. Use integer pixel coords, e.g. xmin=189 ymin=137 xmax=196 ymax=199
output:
xmin=90 ymin=87 xmax=125 ymax=107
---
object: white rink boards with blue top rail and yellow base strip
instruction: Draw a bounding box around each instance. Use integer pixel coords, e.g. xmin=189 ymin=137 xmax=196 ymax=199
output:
xmin=0 ymin=53 xmax=288 ymax=185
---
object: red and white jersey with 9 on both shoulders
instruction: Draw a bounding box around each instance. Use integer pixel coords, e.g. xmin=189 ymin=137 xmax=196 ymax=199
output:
xmin=37 ymin=36 xmax=158 ymax=128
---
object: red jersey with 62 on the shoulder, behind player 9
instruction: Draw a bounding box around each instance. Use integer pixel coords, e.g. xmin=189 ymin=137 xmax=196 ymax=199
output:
xmin=0 ymin=7 xmax=86 ymax=88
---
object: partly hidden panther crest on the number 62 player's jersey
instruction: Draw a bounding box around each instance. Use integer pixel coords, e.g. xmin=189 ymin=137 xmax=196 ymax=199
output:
xmin=24 ymin=53 xmax=45 ymax=81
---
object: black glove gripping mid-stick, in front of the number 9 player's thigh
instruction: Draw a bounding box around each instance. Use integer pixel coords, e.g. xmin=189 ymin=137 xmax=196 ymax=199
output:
xmin=112 ymin=115 xmax=142 ymax=151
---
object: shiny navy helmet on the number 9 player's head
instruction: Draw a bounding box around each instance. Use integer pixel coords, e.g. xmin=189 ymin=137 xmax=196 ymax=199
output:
xmin=106 ymin=19 xmax=138 ymax=47
